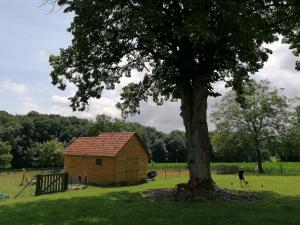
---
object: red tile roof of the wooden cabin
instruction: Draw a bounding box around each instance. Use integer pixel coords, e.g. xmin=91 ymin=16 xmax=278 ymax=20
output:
xmin=64 ymin=132 xmax=135 ymax=157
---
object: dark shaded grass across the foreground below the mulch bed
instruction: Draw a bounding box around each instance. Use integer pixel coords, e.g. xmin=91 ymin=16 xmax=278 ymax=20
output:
xmin=0 ymin=192 xmax=300 ymax=225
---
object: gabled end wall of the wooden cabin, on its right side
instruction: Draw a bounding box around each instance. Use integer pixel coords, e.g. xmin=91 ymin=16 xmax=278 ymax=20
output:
xmin=115 ymin=135 xmax=148 ymax=183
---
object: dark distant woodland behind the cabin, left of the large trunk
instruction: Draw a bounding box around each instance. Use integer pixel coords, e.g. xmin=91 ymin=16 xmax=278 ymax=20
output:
xmin=0 ymin=111 xmax=187 ymax=168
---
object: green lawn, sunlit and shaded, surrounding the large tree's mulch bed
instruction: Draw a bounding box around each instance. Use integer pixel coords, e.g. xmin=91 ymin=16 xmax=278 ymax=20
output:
xmin=0 ymin=173 xmax=300 ymax=225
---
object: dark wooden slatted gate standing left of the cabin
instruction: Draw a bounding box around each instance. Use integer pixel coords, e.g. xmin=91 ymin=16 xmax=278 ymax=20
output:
xmin=35 ymin=173 xmax=69 ymax=196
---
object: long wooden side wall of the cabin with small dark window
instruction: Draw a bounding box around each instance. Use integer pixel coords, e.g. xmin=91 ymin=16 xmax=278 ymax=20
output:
xmin=64 ymin=155 xmax=115 ymax=184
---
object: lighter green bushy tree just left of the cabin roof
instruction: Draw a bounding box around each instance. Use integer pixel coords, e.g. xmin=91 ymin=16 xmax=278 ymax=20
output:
xmin=36 ymin=140 xmax=64 ymax=168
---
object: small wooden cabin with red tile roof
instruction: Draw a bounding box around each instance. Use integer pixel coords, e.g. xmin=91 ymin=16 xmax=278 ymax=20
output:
xmin=64 ymin=132 xmax=149 ymax=184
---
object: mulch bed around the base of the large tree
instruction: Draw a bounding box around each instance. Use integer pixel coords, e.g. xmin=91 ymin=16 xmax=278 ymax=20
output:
xmin=143 ymin=188 xmax=262 ymax=202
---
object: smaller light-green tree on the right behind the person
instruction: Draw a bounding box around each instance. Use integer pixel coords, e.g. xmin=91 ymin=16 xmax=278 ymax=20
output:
xmin=212 ymin=81 xmax=289 ymax=173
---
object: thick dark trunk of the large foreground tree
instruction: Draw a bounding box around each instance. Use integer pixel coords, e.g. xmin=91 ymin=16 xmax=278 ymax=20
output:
xmin=181 ymin=77 xmax=216 ymax=190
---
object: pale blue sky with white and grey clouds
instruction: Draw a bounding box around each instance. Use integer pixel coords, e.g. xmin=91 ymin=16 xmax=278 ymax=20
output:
xmin=0 ymin=0 xmax=300 ymax=132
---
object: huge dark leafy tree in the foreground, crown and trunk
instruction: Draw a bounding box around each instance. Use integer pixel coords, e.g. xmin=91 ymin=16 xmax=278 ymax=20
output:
xmin=49 ymin=0 xmax=300 ymax=190
